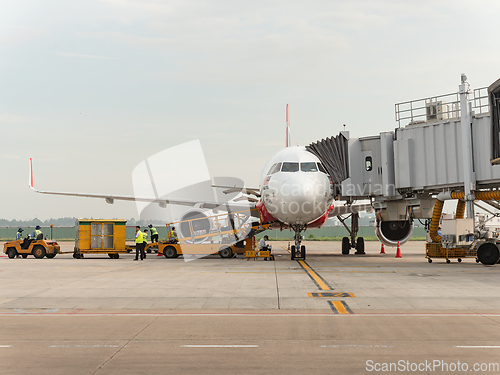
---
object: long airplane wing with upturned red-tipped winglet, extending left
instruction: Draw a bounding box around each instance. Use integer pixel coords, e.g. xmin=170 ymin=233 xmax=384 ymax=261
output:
xmin=29 ymin=158 xmax=255 ymax=212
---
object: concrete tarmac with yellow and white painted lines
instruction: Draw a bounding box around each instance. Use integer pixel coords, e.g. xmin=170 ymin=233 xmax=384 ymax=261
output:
xmin=0 ymin=241 xmax=500 ymax=375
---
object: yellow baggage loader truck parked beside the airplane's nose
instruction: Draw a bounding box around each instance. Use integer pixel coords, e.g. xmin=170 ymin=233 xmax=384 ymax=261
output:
xmin=158 ymin=209 xmax=270 ymax=258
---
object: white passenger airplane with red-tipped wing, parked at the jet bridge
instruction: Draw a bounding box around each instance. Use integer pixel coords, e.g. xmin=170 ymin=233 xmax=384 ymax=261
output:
xmin=30 ymin=104 xmax=372 ymax=259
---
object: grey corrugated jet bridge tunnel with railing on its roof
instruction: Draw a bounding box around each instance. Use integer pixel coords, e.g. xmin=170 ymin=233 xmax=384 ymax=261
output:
xmin=342 ymin=75 xmax=500 ymax=200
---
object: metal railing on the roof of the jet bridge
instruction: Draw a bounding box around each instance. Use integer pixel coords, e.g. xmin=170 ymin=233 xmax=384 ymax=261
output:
xmin=395 ymin=87 xmax=490 ymax=127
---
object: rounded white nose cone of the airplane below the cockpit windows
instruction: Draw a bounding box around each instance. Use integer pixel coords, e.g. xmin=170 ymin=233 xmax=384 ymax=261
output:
xmin=275 ymin=175 xmax=328 ymax=224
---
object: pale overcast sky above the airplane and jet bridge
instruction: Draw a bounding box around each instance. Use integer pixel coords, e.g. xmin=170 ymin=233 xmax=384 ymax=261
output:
xmin=0 ymin=0 xmax=500 ymax=220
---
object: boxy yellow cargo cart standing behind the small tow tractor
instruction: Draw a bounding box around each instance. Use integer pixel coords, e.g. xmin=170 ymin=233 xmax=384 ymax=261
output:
xmin=73 ymin=219 xmax=131 ymax=259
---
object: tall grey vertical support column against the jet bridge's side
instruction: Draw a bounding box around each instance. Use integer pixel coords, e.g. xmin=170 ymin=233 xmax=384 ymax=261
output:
xmin=459 ymin=74 xmax=476 ymax=219
